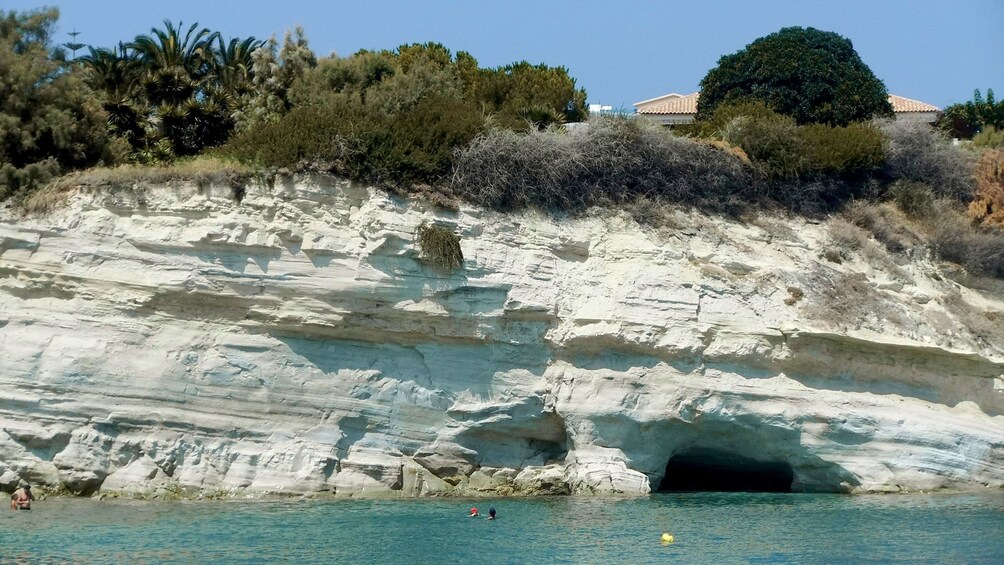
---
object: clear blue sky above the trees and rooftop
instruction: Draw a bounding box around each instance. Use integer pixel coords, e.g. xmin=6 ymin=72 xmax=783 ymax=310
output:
xmin=7 ymin=0 xmax=1004 ymax=108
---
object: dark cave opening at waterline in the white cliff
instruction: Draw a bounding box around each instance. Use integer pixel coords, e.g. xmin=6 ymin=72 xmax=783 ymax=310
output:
xmin=659 ymin=449 xmax=795 ymax=493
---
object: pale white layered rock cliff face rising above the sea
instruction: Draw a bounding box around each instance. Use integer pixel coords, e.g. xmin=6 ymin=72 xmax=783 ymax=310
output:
xmin=0 ymin=177 xmax=1004 ymax=496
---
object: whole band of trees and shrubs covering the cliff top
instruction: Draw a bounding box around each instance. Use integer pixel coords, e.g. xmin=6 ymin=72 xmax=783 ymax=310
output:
xmin=0 ymin=9 xmax=1004 ymax=277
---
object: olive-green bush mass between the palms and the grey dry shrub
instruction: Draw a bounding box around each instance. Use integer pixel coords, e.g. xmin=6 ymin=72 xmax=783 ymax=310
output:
xmin=222 ymin=43 xmax=585 ymax=185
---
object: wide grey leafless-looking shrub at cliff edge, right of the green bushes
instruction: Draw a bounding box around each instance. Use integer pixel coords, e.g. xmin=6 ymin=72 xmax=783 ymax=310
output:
xmin=451 ymin=118 xmax=751 ymax=211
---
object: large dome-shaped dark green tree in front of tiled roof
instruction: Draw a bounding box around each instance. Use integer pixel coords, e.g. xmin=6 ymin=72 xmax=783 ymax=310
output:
xmin=697 ymin=27 xmax=893 ymax=125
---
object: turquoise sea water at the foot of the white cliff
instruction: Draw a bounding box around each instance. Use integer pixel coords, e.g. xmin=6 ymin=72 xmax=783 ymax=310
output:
xmin=0 ymin=492 xmax=1004 ymax=564
